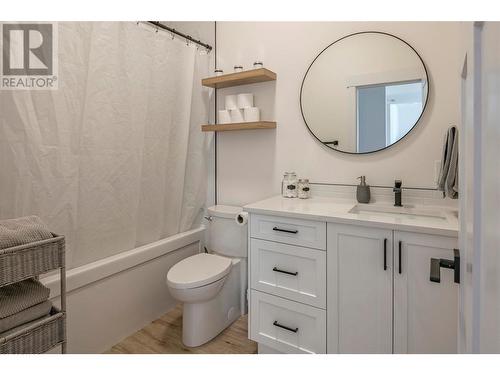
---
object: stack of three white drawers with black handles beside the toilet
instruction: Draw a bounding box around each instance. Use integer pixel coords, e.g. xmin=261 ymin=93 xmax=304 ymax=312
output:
xmin=249 ymin=214 xmax=327 ymax=353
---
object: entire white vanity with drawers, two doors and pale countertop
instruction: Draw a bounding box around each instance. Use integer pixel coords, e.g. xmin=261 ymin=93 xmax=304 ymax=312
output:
xmin=246 ymin=198 xmax=458 ymax=354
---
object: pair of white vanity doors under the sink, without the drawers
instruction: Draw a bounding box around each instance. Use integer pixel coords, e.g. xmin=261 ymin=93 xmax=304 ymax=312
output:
xmin=327 ymin=223 xmax=458 ymax=353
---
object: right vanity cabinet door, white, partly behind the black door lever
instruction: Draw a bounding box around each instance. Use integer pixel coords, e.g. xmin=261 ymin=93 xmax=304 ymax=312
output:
xmin=394 ymin=231 xmax=458 ymax=353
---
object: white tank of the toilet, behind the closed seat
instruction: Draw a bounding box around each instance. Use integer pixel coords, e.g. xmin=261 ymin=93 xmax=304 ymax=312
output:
xmin=207 ymin=205 xmax=248 ymax=258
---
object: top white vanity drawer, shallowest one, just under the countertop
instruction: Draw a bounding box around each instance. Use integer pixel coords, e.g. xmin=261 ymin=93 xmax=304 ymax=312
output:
xmin=250 ymin=214 xmax=326 ymax=250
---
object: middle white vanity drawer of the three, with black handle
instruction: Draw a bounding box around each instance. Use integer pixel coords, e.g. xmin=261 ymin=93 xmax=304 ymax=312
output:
xmin=250 ymin=238 xmax=326 ymax=308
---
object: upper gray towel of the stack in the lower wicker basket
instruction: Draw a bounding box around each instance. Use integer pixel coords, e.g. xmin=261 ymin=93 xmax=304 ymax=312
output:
xmin=0 ymin=279 xmax=50 ymax=319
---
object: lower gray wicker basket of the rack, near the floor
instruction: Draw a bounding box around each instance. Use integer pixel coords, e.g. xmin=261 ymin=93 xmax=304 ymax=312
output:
xmin=0 ymin=308 xmax=66 ymax=354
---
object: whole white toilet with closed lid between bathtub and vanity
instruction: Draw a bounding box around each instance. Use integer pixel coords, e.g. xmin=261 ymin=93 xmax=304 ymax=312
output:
xmin=167 ymin=205 xmax=248 ymax=347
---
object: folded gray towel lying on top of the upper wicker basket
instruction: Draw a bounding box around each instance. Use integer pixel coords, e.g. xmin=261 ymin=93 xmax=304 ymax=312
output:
xmin=0 ymin=216 xmax=53 ymax=250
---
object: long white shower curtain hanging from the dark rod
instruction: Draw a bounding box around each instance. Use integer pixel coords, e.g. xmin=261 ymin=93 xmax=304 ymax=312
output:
xmin=0 ymin=22 xmax=210 ymax=267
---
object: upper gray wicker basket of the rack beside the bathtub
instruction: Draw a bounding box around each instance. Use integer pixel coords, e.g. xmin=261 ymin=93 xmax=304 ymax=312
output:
xmin=0 ymin=233 xmax=64 ymax=287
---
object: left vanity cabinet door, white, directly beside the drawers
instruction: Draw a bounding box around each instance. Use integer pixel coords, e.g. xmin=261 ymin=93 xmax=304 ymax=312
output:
xmin=327 ymin=223 xmax=393 ymax=353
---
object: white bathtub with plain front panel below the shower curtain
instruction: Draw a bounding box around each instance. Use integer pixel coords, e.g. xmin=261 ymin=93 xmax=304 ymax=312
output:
xmin=41 ymin=226 xmax=205 ymax=353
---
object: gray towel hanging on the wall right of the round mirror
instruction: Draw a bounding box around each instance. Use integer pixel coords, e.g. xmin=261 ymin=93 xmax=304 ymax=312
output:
xmin=438 ymin=126 xmax=458 ymax=199
